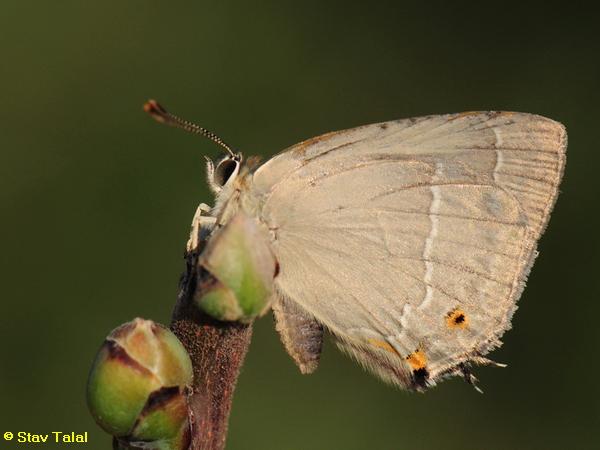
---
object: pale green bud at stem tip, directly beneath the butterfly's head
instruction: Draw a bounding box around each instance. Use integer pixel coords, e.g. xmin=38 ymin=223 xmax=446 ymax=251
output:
xmin=194 ymin=213 xmax=276 ymax=322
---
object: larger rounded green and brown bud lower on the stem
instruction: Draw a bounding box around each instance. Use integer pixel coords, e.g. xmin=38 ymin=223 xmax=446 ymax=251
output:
xmin=87 ymin=319 xmax=193 ymax=449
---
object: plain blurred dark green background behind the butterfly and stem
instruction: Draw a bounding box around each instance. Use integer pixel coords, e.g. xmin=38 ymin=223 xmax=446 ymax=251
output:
xmin=0 ymin=0 xmax=600 ymax=450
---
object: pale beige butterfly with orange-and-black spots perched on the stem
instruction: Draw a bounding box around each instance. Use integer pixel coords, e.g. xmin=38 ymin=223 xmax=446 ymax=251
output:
xmin=145 ymin=101 xmax=567 ymax=391
